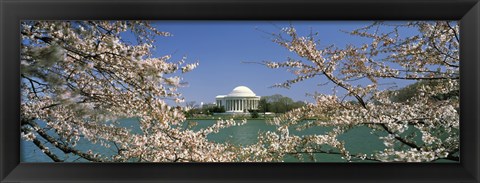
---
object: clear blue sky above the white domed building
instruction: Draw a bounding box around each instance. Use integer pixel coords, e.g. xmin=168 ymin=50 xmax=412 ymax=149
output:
xmin=147 ymin=21 xmax=412 ymax=104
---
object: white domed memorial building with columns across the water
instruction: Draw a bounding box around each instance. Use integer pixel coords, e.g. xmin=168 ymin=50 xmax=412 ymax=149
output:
xmin=215 ymin=86 xmax=260 ymax=113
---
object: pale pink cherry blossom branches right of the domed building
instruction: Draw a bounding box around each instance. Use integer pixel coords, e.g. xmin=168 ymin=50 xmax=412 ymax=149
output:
xmin=258 ymin=21 xmax=460 ymax=162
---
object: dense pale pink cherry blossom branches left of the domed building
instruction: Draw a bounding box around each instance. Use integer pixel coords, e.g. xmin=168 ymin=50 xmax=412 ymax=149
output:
xmin=21 ymin=21 xmax=248 ymax=162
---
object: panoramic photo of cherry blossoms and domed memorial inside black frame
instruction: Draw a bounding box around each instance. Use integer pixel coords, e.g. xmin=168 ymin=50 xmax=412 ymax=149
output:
xmin=20 ymin=20 xmax=460 ymax=163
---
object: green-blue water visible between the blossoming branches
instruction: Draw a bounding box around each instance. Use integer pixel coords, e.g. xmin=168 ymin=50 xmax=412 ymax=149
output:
xmin=20 ymin=118 xmax=456 ymax=162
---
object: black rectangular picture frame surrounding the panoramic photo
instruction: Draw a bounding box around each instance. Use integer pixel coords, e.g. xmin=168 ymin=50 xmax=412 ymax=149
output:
xmin=0 ymin=0 xmax=480 ymax=182
